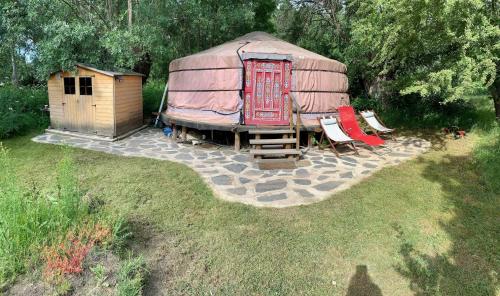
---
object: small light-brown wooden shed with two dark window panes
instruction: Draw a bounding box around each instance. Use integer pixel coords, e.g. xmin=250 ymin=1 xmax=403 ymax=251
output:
xmin=47 ymin=64 xmax=144 ymax=138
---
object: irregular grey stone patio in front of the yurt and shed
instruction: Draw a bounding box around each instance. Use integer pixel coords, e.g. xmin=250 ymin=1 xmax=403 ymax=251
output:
xmin=33 ymin=128 xmax=430 ymax=207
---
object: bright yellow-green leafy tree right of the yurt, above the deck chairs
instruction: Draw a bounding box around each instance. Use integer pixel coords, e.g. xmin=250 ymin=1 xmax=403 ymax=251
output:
xmin=349 ymin=0 xmax=500 ymax=117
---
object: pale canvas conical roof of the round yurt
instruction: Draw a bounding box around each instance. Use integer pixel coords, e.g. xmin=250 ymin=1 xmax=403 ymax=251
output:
xmin=170 ymin=32 xmax=346 ymax=73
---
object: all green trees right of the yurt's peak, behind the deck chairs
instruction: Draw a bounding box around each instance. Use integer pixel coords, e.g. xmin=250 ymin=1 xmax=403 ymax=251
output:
xmin=277 ymin=0 xmax=500 ymax=118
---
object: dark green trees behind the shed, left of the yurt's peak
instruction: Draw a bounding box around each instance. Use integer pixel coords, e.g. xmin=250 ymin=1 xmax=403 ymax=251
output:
xmin=0 ymin=0 xmax=276 ymax=81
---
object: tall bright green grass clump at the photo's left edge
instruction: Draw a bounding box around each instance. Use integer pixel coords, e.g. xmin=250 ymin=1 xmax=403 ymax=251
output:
xmin=0 ymin=146 xmax=88 ymax=286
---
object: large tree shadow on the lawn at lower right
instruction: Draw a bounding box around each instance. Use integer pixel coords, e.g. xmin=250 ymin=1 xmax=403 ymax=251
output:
xmin=394 ymin=156 xmax=500 ymax=296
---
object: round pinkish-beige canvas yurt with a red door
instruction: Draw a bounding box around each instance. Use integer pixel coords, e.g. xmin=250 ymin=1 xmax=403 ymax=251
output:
xmin=162 ymin=32 xmax=349 ymax=154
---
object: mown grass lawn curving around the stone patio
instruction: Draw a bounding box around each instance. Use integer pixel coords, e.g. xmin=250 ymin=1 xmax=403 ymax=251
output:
xmin=4 ymin=134 xmax=500 ymax=295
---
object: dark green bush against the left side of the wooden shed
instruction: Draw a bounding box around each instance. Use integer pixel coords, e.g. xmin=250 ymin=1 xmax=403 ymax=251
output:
xmin=0 ymin=84 xmax=49 ymax=139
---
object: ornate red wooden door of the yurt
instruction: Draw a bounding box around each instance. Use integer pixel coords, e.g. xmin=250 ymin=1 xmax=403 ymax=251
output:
xmin=244 ymin=60 xmax=292 ymax=125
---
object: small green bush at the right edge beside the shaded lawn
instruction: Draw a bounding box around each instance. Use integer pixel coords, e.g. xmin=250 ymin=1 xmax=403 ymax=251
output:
xmin=474 ymin=124 xmax=500 ymax=194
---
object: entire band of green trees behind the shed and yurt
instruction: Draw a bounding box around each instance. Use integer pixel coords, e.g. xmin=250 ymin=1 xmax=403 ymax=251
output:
xmin=0 ymin=0 xmax=500 ymax=118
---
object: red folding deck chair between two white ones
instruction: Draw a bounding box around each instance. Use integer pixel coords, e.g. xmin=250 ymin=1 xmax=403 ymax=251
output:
xmin=337 ymin=106 xmax=384 ymax=146
